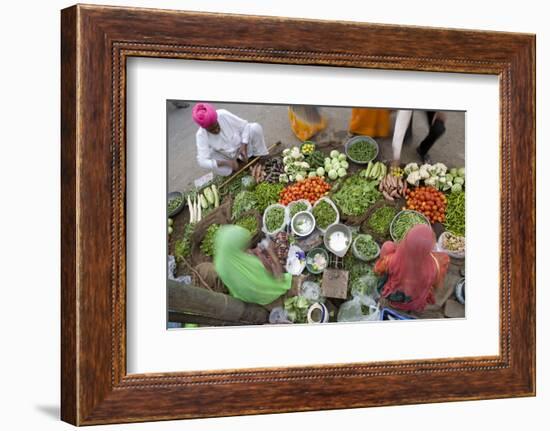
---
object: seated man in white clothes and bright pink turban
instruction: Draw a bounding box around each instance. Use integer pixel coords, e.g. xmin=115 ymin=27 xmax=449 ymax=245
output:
xmin=193 ymin=102 xmax=268 ymax=176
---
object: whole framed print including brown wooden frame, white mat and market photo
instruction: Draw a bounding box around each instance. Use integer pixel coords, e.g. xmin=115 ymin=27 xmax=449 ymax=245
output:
xmin=61 ymin=5 xmax=535 ymax=425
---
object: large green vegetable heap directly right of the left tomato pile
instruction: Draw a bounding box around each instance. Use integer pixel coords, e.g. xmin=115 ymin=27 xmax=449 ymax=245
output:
xmin=332 ymin=175 xmax=381 ymax=216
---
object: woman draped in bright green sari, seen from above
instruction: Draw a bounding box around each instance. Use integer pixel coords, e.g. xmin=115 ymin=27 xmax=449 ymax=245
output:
xmin=214 ymin=225 xmax=292 ymax=305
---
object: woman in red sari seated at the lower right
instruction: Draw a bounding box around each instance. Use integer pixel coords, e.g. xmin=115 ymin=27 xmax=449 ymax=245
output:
xmin=374 ymin=224 xmax=449 ymax=311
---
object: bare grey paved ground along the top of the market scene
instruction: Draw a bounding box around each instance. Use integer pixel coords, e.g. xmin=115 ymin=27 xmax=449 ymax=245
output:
xmin=167 ymin=102 xmax=465 ymax=191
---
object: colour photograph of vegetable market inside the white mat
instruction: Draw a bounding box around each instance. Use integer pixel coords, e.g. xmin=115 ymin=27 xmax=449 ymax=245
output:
xmin=166 ymin=100 xmax=466 ymax=330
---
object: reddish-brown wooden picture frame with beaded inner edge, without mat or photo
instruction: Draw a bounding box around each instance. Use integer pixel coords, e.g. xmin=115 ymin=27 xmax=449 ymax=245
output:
xmin=61 ymin=5 xmax=535 ymax=425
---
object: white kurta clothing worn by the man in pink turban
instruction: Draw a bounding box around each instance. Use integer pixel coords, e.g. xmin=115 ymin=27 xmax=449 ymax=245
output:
xmin=196 ymin=109 xmax=268 ymax=175
